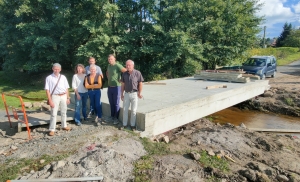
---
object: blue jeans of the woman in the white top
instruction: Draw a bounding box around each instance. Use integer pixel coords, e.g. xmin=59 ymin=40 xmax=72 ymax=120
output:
xmin=74 ymin=92 xmax=88 ymax=123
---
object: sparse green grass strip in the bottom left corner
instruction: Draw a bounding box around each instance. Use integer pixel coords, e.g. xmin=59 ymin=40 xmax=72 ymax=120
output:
xmin=0 ymin=153 xmax=71 ymax=181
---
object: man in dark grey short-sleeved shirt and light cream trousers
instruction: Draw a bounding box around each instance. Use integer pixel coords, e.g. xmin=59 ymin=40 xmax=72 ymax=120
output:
xmin=120 ymin=60 xmax=144 ymax=131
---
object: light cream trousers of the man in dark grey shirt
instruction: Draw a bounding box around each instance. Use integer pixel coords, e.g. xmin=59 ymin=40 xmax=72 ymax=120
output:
xmin=123 ymin=92 xmax=138 ymax=127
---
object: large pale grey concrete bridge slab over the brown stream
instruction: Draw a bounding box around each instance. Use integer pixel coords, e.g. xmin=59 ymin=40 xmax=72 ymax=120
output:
xmin=101 ymin=77 xmax=269 ymax=137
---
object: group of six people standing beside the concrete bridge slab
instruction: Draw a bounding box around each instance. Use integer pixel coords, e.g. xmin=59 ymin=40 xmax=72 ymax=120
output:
xmin=45 ymin=54 xmax=144 ymax=136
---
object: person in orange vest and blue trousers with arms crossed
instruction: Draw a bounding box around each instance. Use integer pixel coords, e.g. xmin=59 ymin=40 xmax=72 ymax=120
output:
xmin=84 ymin=64 xmax=102 ymax=123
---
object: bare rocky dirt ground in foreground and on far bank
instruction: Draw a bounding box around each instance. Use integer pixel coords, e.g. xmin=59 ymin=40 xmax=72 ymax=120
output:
xmin=0 ymin=61 xmax=300 ymax=182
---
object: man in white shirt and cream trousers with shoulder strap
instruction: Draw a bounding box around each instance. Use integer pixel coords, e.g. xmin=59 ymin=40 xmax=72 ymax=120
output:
xmin=45 ymin=63 xmax=70 ymax=136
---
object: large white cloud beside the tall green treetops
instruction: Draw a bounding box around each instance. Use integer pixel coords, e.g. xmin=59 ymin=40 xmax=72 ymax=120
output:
xmin=257 ymin=0 xmax=295 ymax=28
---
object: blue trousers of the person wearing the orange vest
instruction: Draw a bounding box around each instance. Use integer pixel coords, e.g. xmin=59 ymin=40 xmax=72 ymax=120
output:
xmin=88 ymin=89 xmax=102 ymax=118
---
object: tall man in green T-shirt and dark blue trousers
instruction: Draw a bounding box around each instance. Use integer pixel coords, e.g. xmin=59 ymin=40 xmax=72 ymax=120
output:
xmin=106 ymin=54 xmax=126 ymax=124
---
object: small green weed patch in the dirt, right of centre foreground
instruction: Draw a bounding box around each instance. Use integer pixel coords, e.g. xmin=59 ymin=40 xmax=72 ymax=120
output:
xmin=199 ymin=150 xmax=229 ymax=172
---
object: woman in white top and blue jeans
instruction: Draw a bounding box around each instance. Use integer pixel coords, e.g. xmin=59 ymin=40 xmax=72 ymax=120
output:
xmin=72 ymin=64 xmax=88 ymax=126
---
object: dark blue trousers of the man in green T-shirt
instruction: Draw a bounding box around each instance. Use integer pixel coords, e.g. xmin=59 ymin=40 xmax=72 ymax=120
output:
xmin=107 ymin=86 xmax=121 ymax=118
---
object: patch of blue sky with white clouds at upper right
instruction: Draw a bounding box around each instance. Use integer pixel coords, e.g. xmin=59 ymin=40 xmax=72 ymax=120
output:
xmin=257 ymin=0 xmax=300 ymax=39
